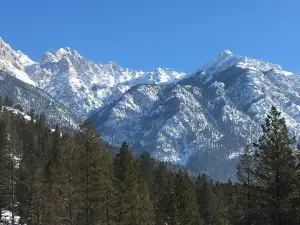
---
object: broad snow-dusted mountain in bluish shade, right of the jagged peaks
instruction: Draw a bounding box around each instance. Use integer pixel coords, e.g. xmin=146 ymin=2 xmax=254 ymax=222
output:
xmin=91 ymin=51 xmax=300 ymax=180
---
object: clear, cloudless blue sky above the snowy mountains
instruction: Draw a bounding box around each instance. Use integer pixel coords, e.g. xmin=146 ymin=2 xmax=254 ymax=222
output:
xmin=0 ymin=0 xmax=300 ymax=72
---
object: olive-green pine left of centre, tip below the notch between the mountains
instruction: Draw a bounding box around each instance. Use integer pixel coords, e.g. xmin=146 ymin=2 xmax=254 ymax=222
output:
xmin=80 ymin=122 xmax=113 ymax=225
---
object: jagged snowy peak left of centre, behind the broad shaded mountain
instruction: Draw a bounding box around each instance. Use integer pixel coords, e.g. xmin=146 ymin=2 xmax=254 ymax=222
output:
xmin=26 ymin=48 xmax=185 ymax=118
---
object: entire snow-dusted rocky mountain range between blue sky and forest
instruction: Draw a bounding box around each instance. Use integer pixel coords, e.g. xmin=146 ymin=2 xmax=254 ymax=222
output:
xmin=0 ymin=36 xmax=300 ymax=180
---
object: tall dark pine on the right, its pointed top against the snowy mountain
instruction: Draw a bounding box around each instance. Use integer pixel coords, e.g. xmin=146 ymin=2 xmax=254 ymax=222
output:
xmin=255 ymin=106 xmax=297 ymax=225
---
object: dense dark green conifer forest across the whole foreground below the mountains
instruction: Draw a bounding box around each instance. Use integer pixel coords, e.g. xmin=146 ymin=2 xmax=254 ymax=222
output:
xmin=0 ymin=98 xmax=300 ymax=225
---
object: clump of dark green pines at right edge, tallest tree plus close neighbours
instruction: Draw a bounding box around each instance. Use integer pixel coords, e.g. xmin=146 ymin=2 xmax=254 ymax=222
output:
xmin=230 ymin=107 xmax=300 ymax=225
